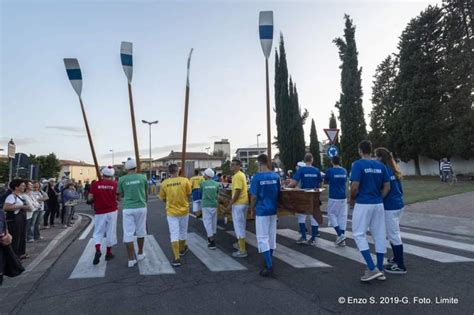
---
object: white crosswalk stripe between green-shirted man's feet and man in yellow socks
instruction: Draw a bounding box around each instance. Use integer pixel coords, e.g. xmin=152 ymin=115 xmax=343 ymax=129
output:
xmin=135 ymin=235 xmax=175 ymax=276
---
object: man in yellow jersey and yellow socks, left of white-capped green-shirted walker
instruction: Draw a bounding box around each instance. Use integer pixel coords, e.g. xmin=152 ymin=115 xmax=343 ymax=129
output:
xmin=160 ymin=164 xmax=191 ymax=267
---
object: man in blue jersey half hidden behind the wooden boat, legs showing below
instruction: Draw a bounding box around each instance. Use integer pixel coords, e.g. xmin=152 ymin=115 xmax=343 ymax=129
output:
xmin=288 ymin=153 xmax=322 ymax=246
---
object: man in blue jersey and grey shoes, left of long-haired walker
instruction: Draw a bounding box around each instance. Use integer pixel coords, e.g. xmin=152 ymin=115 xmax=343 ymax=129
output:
xmin=350 ymin=140 xmax=390 ymax=281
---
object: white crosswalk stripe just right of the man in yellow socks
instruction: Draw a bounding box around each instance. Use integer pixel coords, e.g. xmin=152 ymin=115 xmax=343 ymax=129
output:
xmin=186 ymin=233 xmax=247 ymax=272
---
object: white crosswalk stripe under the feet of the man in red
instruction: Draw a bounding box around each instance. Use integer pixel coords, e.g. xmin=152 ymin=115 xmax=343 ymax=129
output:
xmin=69 ymin=238 xmax=107 ymax=279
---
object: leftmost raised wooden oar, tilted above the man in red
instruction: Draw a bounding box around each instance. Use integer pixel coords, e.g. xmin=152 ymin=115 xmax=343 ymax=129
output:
xmin=64 ymin=58 xmax=100 ymax=179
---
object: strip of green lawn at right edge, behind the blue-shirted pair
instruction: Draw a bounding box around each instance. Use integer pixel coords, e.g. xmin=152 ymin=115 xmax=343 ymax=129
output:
xmin=402 ymin=177 xmax=474 ymax=204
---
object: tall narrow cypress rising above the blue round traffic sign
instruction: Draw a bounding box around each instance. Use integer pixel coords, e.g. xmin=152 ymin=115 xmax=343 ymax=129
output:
xmin=334 ymin=14 xmax=367 ymax=169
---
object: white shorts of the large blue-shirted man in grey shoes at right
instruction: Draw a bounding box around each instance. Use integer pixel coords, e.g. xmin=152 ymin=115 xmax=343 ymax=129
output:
xmin=352 ymin=203 xmax=387 ymax=253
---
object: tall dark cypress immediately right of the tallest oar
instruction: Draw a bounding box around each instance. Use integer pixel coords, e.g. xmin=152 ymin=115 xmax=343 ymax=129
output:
xmin=274 ymin=35 xmax=308 ymax=170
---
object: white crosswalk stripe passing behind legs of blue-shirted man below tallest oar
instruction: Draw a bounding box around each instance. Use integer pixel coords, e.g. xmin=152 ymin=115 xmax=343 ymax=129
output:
xmin=227 ymin=231 xmax=331 ymax=268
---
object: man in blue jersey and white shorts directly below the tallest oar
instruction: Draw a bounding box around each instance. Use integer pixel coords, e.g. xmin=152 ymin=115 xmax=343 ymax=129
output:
xmin=250 ymin=154 xmax=280 ymax=277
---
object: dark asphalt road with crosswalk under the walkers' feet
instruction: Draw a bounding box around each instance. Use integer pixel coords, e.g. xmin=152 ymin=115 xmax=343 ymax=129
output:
xmin=5 ymin=199 xmax=474 ymax=314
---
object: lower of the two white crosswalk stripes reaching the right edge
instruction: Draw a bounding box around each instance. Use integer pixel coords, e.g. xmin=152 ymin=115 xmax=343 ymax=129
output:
xmin=318 ymin=228 xmax=474 ymax=263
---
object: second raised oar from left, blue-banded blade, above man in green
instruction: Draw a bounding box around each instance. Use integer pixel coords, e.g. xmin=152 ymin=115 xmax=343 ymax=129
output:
xmin=120 ymin=42 xmax=141 ymax=173
